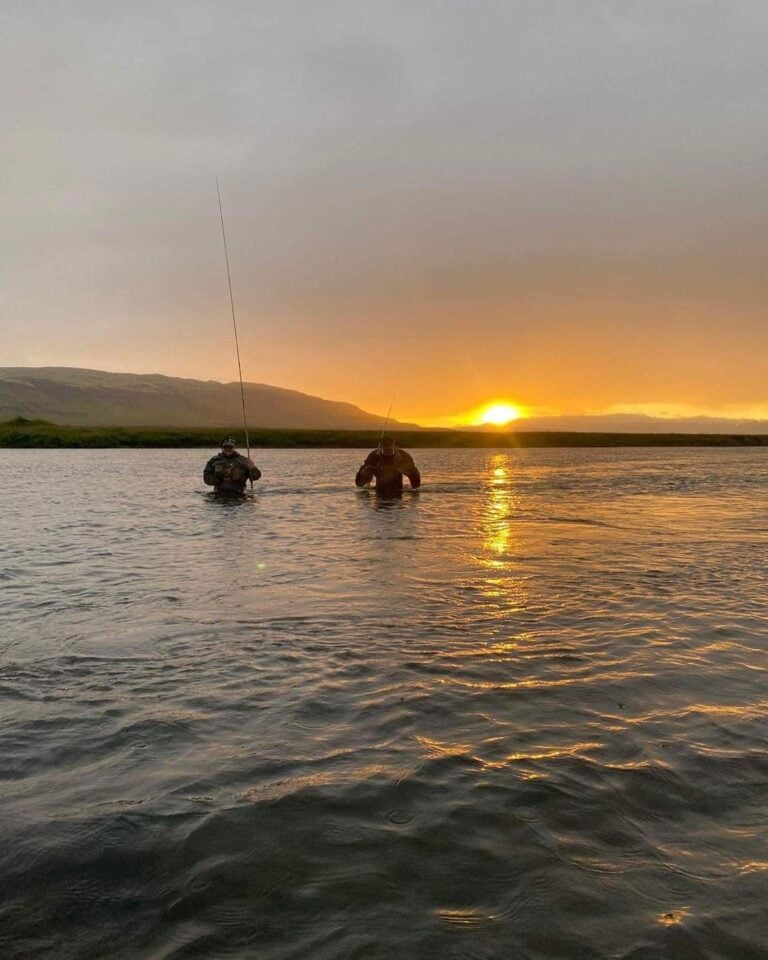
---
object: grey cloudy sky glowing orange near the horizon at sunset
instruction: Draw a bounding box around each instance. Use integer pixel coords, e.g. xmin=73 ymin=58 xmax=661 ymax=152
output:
xmin=0 ymin=0 xmax=768 ymax=421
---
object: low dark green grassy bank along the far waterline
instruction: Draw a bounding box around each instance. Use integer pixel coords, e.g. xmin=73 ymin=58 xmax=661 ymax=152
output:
xmin=0 ymin=417 xmax=768 ymax=449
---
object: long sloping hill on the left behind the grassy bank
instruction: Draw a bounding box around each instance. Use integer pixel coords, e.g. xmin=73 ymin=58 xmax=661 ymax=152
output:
xmin=0 ymin=367 xmax=413 ymax=430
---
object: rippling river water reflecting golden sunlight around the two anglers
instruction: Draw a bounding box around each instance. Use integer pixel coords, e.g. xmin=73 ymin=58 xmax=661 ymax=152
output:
xmin=0 ymin=448 xmax=768 ymax=960
